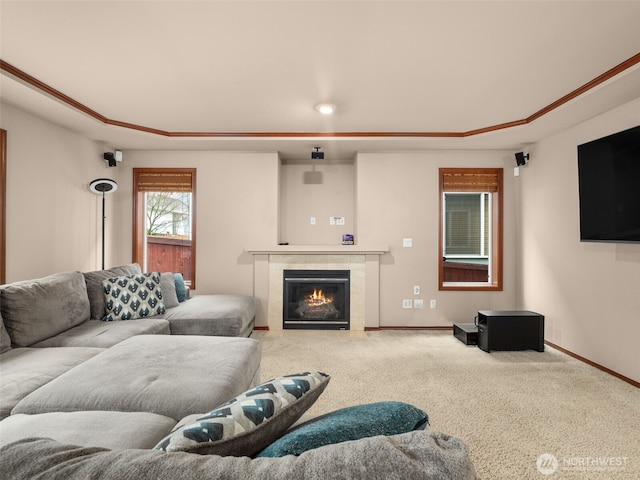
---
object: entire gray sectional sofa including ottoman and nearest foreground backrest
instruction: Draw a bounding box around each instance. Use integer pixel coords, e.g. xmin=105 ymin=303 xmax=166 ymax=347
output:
xmin=0 ymin=264 xmax=475 ymax=480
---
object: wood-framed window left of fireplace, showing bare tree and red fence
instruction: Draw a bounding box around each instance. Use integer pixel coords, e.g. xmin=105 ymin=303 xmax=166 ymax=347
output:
xmin=133 ymin=168 xmax=196 ymax=289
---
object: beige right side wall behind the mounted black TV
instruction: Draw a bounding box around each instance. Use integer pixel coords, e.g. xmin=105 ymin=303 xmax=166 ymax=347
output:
xmin=516 ymin=99 xmax=640 ymax=381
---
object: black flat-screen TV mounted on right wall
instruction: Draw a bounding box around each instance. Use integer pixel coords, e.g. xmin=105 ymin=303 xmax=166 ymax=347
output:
xmin=578 ymin=126 xmax=640 ymax=243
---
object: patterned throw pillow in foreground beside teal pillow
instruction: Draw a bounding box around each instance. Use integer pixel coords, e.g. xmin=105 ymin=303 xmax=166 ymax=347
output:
xmin=154 ymin=372 xmax=330 ymax=457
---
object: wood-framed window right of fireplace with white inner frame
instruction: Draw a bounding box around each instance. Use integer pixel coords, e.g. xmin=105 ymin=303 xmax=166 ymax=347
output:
xmin=438 ymin=168 xmax=503 ymax=290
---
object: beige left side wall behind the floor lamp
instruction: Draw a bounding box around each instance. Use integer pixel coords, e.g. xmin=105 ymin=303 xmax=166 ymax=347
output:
xmin=0 ymin=104 xmax=120 ymax=282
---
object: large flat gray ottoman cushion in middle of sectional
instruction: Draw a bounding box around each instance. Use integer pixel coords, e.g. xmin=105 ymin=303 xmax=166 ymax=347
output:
xmin=12 ymin=334 xmax=261 ymax=420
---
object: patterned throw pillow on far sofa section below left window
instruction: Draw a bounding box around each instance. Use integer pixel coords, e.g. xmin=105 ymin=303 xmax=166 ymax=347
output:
xmin=102 ymin=272 xmax=165 ymax=322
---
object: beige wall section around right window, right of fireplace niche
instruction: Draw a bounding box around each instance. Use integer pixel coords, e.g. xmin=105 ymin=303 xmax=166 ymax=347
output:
xmin=356 ymin=150 xmax=516 ymax=327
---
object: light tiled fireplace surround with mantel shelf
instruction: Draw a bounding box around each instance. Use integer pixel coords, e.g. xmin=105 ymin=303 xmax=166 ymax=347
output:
xmin=249 ymin=246 xmax=387 ymax=331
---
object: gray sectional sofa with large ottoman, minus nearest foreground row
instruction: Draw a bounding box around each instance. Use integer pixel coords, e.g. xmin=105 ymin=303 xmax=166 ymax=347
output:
xmin=0 ymin=264 xmax=261 ymax=424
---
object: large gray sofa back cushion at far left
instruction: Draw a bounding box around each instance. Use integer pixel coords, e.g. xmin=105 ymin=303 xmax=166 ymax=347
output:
xmin=1 ymin=272 xmax=89 ymax=347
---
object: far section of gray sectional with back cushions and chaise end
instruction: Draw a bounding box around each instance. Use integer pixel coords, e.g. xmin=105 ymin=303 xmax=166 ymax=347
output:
xmin=0 ymin=263 xmax=258 ymax=348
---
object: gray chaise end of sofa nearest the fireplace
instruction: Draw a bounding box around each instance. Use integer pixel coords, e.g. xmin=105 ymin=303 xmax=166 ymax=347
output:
xmin=162 ymin=294 xmax=258 ymax=337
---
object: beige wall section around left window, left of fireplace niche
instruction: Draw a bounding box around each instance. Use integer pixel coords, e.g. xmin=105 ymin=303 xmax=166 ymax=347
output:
xmin=117 ymin=151 xmax=279 ymax=295
